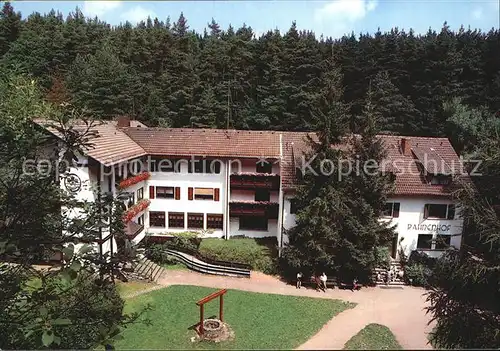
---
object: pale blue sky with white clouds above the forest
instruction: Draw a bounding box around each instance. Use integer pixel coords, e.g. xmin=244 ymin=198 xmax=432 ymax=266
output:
xmin=8 ymin=0 xmax=500 ymax=38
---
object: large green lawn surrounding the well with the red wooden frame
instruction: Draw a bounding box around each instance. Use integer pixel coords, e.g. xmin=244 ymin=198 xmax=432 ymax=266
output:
xmin=115 ymin=286 xmax=354 ymax=349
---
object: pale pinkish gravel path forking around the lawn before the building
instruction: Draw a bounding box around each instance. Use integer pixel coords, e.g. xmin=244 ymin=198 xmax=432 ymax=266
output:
xmin=155 ymin=270 xmax=432 ymax=350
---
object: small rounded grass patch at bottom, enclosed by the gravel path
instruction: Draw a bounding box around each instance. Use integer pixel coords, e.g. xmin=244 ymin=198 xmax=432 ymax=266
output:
xmin=344 ymin=323 xmax=403 ymax=350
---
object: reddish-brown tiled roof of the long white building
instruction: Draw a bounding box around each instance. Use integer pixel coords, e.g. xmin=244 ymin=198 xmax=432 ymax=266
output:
xmin=36 ymin=120 xmax=468 ymax=196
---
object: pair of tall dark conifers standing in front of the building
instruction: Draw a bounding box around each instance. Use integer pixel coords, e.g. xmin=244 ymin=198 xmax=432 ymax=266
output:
xmin=281 ymin=83 xmax=394 ymax=283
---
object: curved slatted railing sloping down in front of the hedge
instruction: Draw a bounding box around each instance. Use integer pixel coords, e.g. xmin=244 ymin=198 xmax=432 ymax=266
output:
xmin=165 ymin=249 xmax=250 ymax=278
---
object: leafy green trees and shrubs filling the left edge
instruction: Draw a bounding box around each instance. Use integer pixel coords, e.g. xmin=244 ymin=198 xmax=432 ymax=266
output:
xmin=0 ymin=72 xmax=139 ymax=349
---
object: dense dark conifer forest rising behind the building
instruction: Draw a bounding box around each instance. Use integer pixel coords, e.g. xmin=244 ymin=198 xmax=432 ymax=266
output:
xmin=0 ymin=2 xmax=500 ymax=142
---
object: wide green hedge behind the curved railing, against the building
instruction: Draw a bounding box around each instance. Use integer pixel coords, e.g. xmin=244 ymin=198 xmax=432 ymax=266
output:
xmin=199 ymin=237 xmax=277 ymax=274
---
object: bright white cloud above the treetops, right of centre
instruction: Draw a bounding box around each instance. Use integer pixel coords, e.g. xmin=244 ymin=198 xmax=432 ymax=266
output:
xmin=314 ymin=0 xmax=377 ymax=23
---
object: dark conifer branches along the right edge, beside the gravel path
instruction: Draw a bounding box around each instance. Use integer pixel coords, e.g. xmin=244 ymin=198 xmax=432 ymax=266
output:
xmin=428 ymin=127 xmax=500 ymax=349
